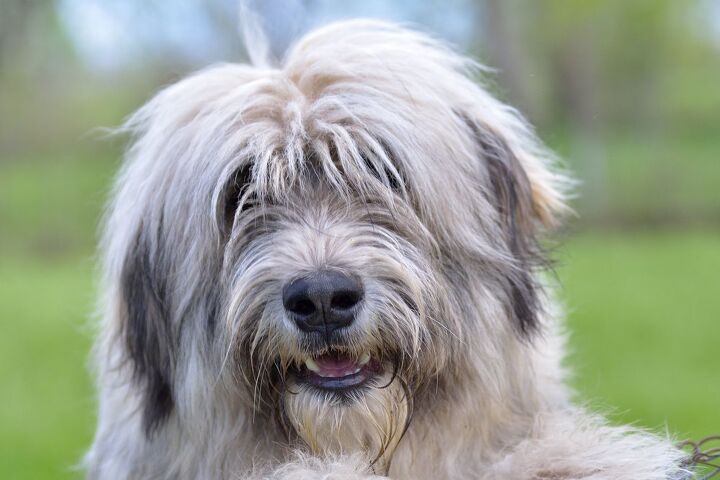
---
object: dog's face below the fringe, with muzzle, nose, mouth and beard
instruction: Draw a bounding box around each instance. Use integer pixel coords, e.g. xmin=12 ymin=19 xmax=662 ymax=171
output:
xmin=224 ymin=176 xmax=442 ymax=464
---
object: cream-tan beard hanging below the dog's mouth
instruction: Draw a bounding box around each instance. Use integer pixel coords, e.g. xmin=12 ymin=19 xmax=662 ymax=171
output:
xmin=282 ymin=371 xmax=412 ymax=473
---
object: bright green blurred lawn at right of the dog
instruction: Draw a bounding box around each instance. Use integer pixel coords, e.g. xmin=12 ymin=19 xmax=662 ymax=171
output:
xmin=560 ymin=231 xmax=720 ymax=437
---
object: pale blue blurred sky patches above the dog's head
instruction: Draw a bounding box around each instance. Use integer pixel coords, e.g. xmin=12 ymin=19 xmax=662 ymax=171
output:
xmin=57 ymin=0 xmax=476 ymax=71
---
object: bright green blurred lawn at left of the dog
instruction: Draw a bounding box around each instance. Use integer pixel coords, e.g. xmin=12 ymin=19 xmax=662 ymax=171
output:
xmin=0 ymin=255 xmax=95 ymax=479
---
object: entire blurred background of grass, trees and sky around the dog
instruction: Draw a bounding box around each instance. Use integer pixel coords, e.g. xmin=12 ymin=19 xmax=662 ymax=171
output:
xmin=0 ymin=0 xmax=720 ymax=479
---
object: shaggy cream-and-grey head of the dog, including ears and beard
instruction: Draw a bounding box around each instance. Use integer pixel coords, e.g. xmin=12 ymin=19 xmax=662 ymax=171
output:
xmin=105 ymin=22 xmax=564 ymax=470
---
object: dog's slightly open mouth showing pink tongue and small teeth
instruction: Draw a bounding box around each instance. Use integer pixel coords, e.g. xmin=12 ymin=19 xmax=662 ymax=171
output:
xmin=297 ymin=351 xmax=382 ymax=392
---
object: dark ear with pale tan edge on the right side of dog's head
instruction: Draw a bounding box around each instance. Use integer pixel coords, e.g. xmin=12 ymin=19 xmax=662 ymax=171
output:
xmin=465 ymin=117 xmax=565 ymax=336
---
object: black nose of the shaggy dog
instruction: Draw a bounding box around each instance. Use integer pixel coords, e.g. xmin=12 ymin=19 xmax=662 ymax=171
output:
xmin=283 ymin=270 xmax=363 ymax=336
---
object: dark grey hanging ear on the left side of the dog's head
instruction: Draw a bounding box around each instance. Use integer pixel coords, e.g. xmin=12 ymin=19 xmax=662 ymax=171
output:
xmin=120 ymin=227 xmax=175 ymax=435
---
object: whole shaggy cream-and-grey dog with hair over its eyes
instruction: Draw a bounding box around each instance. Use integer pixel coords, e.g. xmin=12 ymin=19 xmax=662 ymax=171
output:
xmin=86 ymin=21 xmax=688 ymax=480
